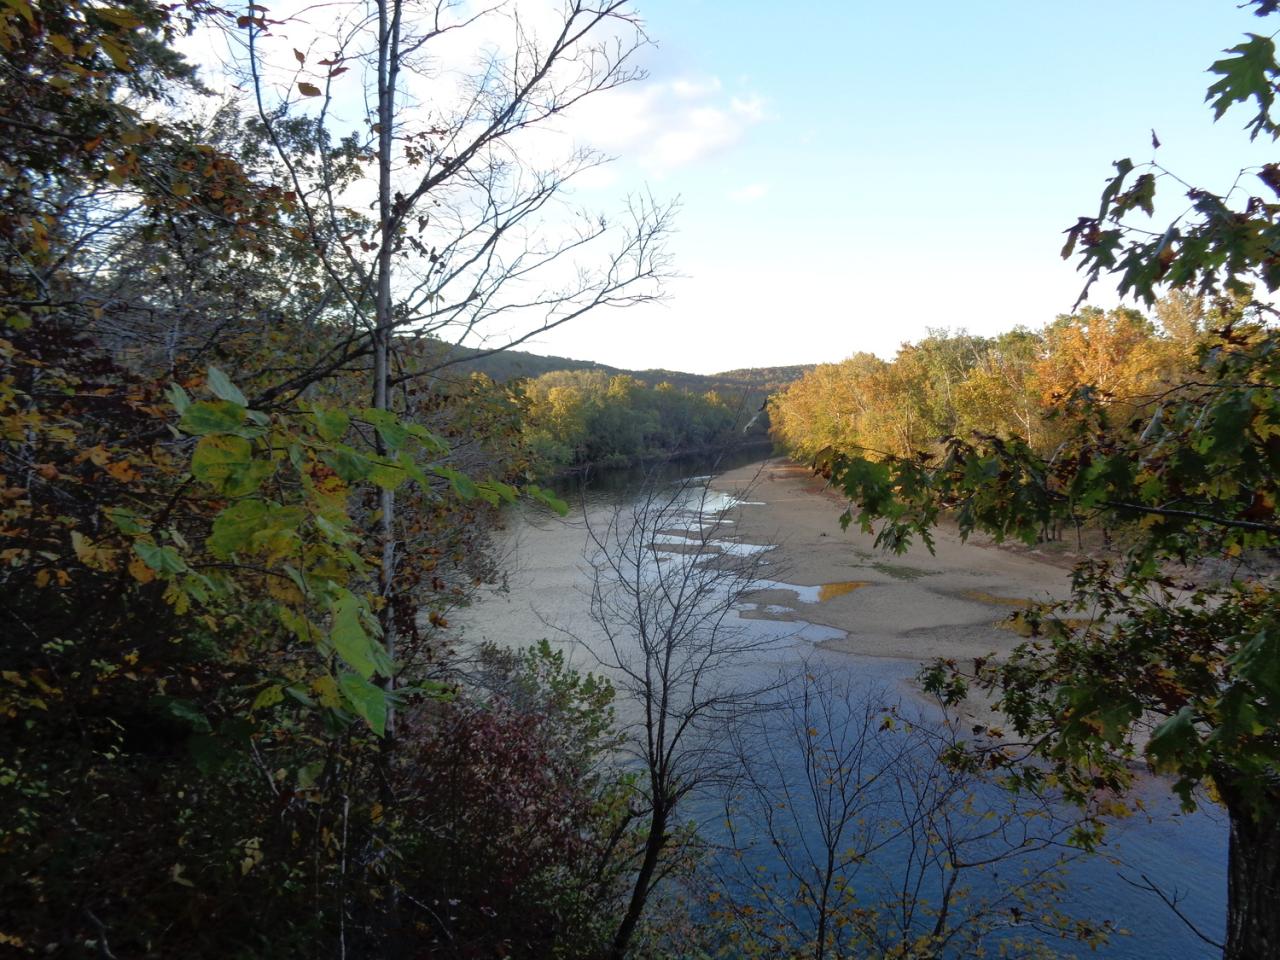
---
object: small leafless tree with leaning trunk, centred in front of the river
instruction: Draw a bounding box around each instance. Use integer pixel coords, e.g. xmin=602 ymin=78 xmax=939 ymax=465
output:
xmin=573 ymin=471 xmax=777 ymax=960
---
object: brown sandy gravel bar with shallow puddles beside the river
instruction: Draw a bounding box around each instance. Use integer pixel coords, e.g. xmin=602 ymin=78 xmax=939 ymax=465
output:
xmin=712 ymin=458 xmax=1070 ymax=663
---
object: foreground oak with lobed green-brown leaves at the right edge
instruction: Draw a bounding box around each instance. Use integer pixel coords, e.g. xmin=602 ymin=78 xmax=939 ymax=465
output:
xmin=826 ymin=0 xmax=1280 ymax=960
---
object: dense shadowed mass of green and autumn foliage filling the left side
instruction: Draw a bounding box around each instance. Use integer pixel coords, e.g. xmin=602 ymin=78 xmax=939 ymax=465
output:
xmin=0 ymin=0 xmax=626 ymax=957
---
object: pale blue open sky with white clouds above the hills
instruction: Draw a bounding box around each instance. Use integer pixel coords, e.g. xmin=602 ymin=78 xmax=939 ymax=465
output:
xmin=192 ymin=0 xmax=1271 ymax=372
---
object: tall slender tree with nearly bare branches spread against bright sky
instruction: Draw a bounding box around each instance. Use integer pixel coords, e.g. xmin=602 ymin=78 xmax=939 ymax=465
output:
xmin=237 ymin=0 xmax=669 ymax=737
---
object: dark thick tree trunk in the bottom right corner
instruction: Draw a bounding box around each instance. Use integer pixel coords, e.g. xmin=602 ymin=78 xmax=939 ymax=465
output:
xmin=1222 ymin=791 xmax=1280 ymax=960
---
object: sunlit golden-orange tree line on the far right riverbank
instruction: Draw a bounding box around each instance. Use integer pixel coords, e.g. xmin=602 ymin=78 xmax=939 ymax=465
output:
xmin=769 ymin=291 xmax=1233 ymax=471
